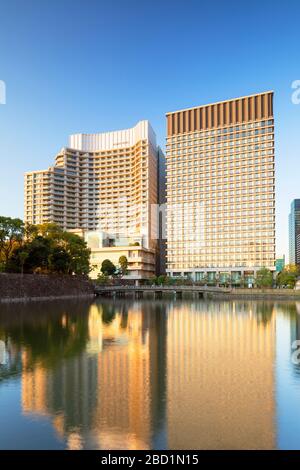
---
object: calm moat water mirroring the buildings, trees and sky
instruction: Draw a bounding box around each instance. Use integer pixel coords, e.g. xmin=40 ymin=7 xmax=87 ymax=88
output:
xmin=0 ymin=299 xmax=300 ymax=449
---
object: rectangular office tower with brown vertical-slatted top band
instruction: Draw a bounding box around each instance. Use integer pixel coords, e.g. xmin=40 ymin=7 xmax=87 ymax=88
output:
xmin=166 ymin=92 xmax=275 ymax=282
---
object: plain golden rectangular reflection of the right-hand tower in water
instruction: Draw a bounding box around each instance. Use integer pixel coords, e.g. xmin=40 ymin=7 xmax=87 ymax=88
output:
xmin=167 ymin=302 xmax=275 ymax=449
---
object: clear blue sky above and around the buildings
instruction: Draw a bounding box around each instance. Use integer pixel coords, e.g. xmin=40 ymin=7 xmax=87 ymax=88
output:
xmin=0 ymin=0 xmax=300 ymax=254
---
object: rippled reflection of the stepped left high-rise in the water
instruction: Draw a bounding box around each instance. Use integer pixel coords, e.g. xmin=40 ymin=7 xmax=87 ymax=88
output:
xmin=22 ymin=302 xmax=166 ymax=449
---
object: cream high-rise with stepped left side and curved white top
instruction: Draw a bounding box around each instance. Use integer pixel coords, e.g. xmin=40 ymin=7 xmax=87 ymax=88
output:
xmin=25 ymin=121 xmax=164 ymax=275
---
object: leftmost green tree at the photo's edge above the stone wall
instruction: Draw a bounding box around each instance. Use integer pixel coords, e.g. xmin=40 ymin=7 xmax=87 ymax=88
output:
xmin=0 ymin=217 xmax=24 ymax=267
